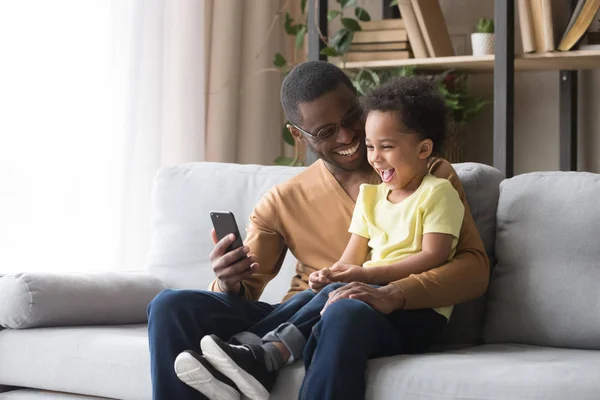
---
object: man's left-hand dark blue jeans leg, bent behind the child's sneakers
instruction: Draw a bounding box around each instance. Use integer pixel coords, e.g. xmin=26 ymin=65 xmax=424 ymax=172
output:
xmin=148 ymin=289 xmax=314 ymax=400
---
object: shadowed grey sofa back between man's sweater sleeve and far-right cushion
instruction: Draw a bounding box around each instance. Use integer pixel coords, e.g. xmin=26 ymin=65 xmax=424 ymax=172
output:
xmin=439 ymin=163 xmax=504 ymax=344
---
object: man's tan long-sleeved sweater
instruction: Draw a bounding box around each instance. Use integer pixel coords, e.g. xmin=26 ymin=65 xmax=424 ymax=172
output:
xmin=210 ymin=158 xmax=489 ymax=309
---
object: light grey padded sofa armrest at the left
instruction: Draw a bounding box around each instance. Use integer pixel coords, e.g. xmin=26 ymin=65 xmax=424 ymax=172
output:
xmin=0 ymin=272 xmax=166 ymax=329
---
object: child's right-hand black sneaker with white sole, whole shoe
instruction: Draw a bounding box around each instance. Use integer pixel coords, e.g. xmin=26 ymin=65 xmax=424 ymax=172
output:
xmin=200 ymin=335 xmax=277 ymax=400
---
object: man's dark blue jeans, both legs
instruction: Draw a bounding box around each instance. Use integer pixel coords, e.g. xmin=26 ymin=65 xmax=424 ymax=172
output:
xmin=148 ymin=284 xmax=446 ymax=400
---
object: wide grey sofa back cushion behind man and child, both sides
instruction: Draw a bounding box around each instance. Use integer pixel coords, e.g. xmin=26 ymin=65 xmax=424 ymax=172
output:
xmin=147 ymin=162 xmax=502 ymax=343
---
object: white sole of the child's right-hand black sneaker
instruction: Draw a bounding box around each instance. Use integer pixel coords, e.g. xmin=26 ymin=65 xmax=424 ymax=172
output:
xmin=200 ymin=335 xmax=270 ymax=400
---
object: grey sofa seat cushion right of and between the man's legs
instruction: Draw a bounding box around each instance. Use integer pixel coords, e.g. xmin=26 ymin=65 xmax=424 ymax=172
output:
xmin=271 ymin=344 xmax=600 ymax=400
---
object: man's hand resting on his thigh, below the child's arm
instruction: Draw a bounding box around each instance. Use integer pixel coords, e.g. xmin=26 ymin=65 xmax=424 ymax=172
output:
xmin=321 ymin=282 xmax=405 ymax=315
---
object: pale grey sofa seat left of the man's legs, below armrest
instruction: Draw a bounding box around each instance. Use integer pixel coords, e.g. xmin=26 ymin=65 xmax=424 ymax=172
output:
xmin=0 ymin=325 xmax=152 ymax=399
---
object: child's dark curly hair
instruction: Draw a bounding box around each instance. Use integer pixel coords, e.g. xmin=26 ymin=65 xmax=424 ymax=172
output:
xmin=361 ymin=76 xmax=449 ymax=155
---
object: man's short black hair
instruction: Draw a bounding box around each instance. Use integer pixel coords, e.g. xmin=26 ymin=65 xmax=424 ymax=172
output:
xmin=281 ymin=61 xmax=356 ymax=125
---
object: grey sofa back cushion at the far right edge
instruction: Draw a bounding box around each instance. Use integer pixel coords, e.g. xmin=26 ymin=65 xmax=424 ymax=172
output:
xmin=484 ymin=172 xmax=600 ymax=349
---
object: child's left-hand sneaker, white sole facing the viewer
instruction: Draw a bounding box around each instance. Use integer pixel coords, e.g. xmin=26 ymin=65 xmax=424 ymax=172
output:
xmin=175 ymin=350 xmax=241 ymax=400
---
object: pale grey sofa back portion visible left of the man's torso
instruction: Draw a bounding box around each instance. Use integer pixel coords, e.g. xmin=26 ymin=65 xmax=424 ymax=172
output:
xmin=147 ymin=162 xmax=304 ymax=303
